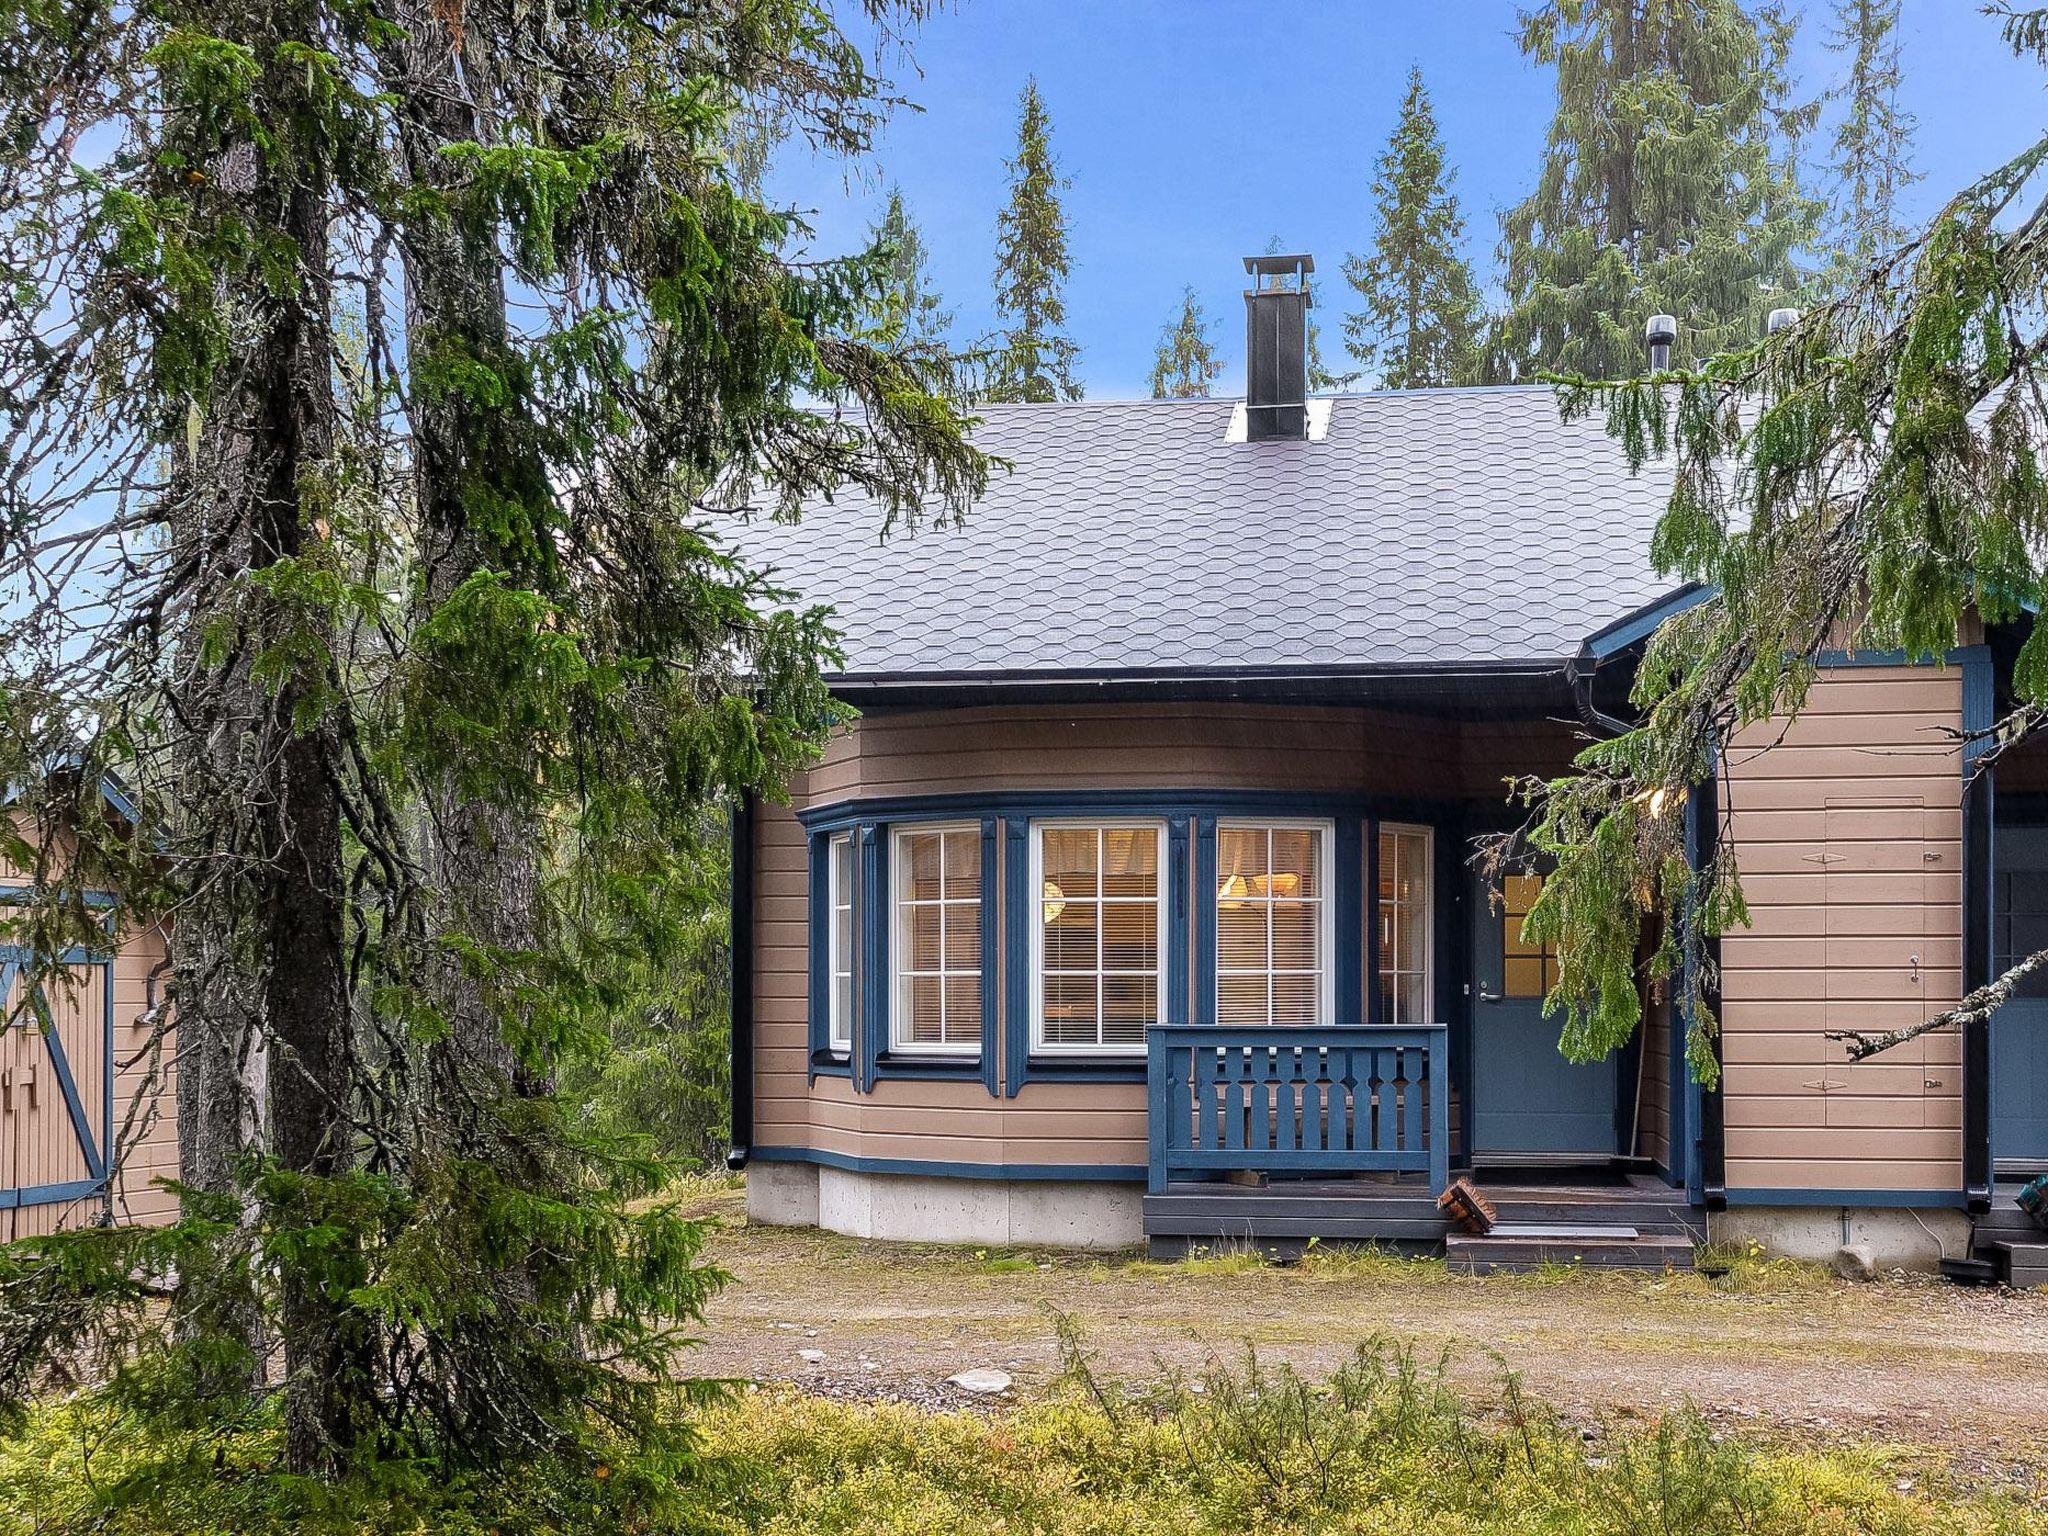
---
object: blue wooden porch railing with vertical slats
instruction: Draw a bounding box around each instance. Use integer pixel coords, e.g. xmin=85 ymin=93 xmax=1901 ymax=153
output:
xmin=1145 ymin=1024 xmax=1450 ymax=1194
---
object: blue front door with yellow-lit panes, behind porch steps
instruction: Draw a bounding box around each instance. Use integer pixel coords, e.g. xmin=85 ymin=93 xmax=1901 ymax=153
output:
xmin=1470 ymin=874 xmax=1616 ymax=1161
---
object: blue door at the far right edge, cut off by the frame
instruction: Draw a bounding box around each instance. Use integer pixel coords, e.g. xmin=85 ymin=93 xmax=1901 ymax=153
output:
xmin=1991 ymin=827 xmax=2048 ymax=1174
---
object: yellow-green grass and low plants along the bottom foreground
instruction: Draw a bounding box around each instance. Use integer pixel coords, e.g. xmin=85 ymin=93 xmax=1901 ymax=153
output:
xmin=0 ymin=1343 xmax=2048 ymax=1536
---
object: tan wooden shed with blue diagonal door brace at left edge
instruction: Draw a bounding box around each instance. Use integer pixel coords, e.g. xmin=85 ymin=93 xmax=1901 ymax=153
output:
xmin=0 ymin=780 xmax=178 ymax=1243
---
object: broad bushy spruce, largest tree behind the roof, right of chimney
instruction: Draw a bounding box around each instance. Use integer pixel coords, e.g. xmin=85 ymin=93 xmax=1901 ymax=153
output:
xmin=1487 ymin=0 xmax=1821 ymax=379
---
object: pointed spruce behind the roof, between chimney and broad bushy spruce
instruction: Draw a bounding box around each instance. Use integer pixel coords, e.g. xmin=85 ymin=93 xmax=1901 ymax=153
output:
xmin=1343 ymin=70 xmax=1479 ymax=389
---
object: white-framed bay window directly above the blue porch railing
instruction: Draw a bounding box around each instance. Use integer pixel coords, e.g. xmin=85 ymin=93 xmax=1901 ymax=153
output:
xmin=1214 ymin=821 xmax=1333 ymax=1026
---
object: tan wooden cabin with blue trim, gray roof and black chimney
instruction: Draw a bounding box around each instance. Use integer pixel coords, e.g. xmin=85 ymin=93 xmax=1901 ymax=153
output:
xmin=733 ymin=258 xmax=2048 ymax=1266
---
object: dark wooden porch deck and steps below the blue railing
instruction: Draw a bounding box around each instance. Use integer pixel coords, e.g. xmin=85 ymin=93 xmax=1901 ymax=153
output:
xmin=1145 ymin=1171 xmax=1706 ymax=1268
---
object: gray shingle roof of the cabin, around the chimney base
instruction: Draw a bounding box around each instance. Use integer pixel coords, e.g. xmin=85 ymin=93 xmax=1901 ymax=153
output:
xmin=737 ymin=387 xmax=1673 ymax=678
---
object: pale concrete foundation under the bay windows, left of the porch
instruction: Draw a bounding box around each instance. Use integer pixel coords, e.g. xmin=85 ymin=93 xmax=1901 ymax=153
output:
xmin=748 ymin=1163 xmax=1145 ymax=1249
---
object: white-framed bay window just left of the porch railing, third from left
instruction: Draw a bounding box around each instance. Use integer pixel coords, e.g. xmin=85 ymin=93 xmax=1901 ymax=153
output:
xmin=1030 ymin=821 xmax=1165 ymax=1055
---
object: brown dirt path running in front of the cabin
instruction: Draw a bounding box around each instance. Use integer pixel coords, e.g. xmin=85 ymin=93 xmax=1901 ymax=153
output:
xmin=698 ymin=1192 xmax=2048 ymax=1475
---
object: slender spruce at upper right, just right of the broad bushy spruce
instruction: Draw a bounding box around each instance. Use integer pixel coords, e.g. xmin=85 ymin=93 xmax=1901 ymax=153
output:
xmin=1827 ymin=0 xmax=1919 ymax=289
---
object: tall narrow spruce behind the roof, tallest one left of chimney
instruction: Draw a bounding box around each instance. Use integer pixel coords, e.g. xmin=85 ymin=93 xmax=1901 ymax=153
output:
xmin=983 ymin=78 xmax=1081 ymax=401
